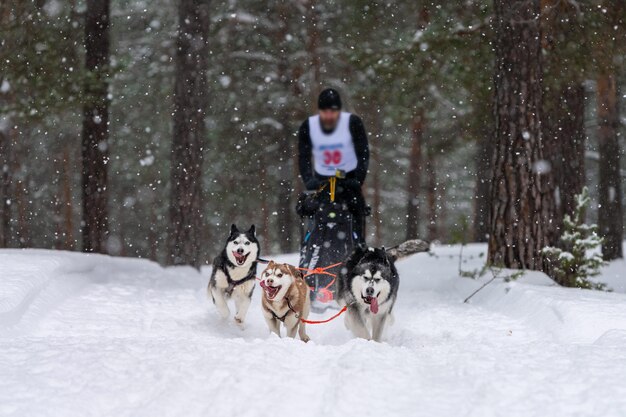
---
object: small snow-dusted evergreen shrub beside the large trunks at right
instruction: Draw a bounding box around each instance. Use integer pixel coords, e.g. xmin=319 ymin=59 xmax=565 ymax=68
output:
xmin=543 ymin=187 xmax=605 ymax=290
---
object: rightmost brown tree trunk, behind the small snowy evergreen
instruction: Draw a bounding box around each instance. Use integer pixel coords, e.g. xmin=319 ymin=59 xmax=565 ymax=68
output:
xmin=597 ymin=70 xmax=624 ymax=260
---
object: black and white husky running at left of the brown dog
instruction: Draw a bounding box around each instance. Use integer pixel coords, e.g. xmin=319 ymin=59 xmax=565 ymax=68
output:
xmin=208 ymin=224 xmax=260 ymax=326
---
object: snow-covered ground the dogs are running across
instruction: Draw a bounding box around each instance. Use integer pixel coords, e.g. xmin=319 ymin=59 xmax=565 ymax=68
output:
xmin=0 ymin=245 xmax=626 ymax=417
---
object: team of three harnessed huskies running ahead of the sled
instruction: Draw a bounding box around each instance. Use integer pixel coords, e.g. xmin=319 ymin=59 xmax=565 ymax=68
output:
xmin=208 ymin=225 xmax=427 ymax=342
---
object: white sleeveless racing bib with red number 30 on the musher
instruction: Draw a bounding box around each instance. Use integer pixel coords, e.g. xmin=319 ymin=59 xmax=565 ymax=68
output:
xmin=309 ymin=112 xmax=358 ymax=177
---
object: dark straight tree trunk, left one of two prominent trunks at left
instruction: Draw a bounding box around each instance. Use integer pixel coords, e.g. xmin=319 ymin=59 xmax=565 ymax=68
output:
xmin=82 ymin=0 xmax=110 ymax=253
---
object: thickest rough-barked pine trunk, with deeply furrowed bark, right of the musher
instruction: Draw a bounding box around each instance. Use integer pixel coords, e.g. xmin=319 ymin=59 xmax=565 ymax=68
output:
xmin=488 ymin=0 xmax=550 ymax=269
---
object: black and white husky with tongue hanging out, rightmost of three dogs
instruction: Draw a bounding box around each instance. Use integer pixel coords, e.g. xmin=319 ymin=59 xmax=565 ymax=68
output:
xmin=337 ymin=240 xmax=429 ymax=342
